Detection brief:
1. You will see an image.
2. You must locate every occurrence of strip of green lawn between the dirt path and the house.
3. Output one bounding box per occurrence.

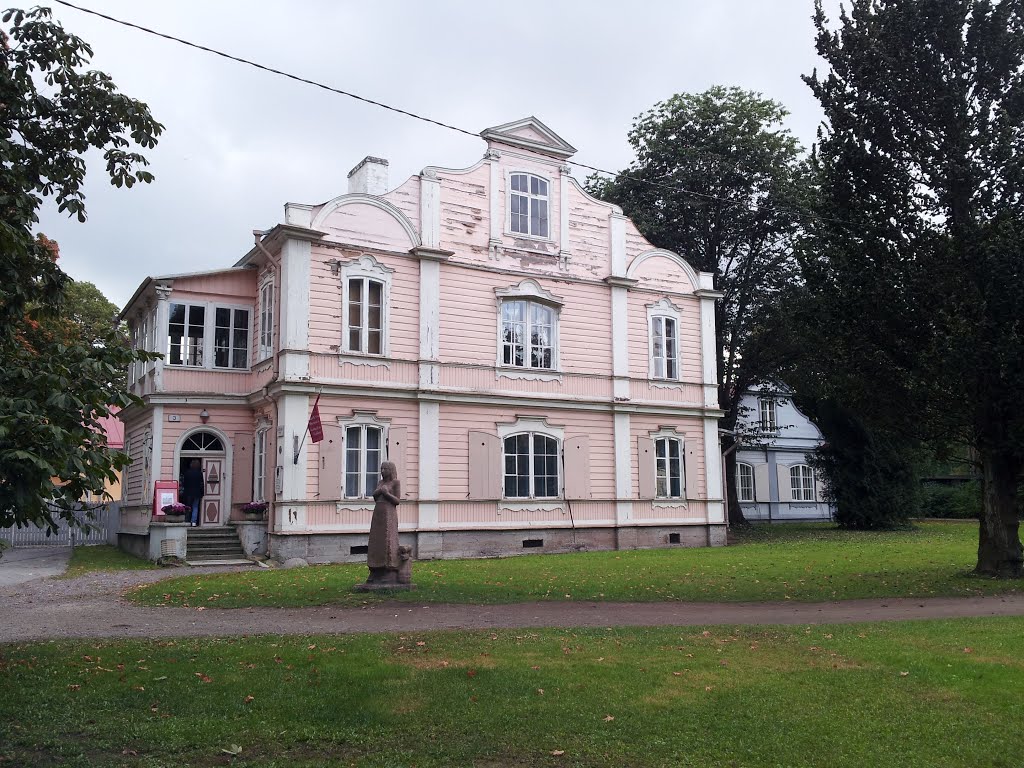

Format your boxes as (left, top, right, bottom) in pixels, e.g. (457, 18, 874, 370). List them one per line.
(128, 522, 1024, 608)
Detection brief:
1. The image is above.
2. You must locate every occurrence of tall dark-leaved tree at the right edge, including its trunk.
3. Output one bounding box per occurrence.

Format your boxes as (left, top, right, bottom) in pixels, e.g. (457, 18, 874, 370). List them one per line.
(802, 0, 1024, 575)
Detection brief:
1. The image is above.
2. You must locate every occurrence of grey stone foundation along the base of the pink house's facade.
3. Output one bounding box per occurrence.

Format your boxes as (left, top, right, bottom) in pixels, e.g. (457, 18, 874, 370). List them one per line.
(268, 525, 726, 563)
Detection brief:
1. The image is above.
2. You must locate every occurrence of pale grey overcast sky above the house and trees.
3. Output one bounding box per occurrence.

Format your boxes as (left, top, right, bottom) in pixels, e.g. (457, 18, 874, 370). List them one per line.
(32, 0, 839, 306)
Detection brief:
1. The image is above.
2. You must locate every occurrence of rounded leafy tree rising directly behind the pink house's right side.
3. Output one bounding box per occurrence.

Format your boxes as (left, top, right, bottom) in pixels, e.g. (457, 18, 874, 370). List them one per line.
(589, 87, 807, 523)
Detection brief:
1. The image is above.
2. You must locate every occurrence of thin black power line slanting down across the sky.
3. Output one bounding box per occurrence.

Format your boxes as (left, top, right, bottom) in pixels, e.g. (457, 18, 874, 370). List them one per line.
(53, 0, 853, 226)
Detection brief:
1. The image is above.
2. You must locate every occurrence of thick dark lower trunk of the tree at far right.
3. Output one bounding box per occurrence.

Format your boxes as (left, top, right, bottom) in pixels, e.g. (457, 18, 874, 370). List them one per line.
(975, 452, 1024, 579)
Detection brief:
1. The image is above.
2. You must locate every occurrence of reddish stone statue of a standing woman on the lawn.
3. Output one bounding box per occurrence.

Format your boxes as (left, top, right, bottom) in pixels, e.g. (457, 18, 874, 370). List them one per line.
(355, 462, 413, 592)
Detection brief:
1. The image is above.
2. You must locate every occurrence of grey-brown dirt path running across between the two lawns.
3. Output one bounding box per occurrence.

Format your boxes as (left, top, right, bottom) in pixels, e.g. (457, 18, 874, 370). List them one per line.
(0, 567, 1024, 642)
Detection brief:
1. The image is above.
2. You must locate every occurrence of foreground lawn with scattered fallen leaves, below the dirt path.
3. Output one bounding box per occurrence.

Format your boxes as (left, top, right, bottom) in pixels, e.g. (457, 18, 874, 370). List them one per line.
(0, 618, 1024, 768)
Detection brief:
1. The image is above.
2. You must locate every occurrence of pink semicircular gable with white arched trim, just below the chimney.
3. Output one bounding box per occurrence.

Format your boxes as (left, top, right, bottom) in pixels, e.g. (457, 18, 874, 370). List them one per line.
(310, 194, 420, 251)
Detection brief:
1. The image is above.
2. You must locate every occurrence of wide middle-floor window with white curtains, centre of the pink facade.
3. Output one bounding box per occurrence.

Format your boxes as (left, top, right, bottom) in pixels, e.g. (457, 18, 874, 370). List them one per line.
(495, 280, 563, 372)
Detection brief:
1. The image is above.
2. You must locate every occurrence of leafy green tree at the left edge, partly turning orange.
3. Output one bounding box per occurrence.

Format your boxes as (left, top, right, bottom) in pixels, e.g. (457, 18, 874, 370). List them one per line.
(0, 8, 163, 527)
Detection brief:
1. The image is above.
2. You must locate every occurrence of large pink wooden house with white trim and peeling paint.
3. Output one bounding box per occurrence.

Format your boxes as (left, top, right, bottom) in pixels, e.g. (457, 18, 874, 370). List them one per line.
(122, 118, 725, 561)
